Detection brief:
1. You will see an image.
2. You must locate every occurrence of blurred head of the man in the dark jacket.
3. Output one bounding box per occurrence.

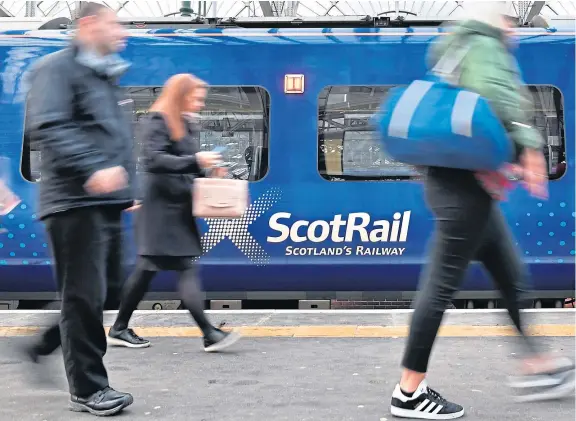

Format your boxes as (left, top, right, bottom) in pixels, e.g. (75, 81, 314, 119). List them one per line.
(76, 2, 126, 55)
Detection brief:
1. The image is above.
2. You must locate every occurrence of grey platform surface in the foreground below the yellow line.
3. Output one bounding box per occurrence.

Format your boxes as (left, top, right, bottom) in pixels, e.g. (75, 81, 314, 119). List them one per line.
(0, 337, 574, 421)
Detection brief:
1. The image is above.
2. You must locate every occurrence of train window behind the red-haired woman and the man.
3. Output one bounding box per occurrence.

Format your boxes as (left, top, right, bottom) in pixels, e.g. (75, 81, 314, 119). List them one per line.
(21, 86, 270, 182)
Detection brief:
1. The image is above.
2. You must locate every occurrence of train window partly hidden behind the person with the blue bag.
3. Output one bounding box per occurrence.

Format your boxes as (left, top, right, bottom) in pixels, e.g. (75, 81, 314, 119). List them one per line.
(318, 86, 566, 181)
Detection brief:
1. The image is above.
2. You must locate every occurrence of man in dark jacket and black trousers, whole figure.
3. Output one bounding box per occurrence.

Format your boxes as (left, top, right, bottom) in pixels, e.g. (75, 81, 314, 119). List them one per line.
(28, 2, 135, 416)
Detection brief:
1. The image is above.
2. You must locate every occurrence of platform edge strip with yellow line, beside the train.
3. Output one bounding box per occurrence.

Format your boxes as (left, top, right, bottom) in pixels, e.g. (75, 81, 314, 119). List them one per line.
(0, 309, 576, 338)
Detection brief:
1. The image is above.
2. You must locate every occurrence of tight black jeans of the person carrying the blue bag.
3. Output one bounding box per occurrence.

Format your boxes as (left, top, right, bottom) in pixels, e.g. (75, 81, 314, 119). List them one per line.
(403, 168, 535, 373)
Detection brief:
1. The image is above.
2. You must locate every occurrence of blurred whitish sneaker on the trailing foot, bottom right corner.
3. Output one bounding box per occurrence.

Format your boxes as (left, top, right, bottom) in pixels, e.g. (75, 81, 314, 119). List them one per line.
(509, 358, 576, 402)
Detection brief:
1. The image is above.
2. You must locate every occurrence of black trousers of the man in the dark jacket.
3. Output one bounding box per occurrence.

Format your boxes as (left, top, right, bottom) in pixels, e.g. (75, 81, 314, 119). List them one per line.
(36, 206, 123, 397)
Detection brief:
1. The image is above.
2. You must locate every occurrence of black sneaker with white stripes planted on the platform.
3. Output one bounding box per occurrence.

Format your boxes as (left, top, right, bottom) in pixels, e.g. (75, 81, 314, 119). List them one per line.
(390, 380, 464, 420)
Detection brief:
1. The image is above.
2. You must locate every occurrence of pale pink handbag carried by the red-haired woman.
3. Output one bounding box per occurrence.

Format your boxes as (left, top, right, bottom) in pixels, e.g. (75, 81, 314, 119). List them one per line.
(192, 177, 249, 218)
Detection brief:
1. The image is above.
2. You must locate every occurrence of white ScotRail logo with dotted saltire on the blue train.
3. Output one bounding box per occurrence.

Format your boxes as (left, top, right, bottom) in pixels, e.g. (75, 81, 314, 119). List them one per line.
(202, 188, 411, 266)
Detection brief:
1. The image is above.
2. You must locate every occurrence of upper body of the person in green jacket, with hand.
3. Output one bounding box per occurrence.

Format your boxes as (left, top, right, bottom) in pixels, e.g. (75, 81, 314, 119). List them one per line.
(427, 9, 547, 197)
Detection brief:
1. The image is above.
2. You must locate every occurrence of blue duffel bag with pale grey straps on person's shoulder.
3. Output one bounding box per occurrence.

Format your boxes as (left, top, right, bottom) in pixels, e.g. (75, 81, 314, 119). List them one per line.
(373, 40, 514, 171)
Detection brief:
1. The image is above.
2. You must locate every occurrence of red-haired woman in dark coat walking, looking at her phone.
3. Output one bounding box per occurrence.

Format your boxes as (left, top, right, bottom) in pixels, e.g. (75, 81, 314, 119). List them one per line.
(108, 74, 239, 352)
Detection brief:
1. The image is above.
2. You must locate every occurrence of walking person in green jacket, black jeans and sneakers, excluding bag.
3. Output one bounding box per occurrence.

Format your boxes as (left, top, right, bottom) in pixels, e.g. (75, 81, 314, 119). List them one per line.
(391, 2, 574, 420)
